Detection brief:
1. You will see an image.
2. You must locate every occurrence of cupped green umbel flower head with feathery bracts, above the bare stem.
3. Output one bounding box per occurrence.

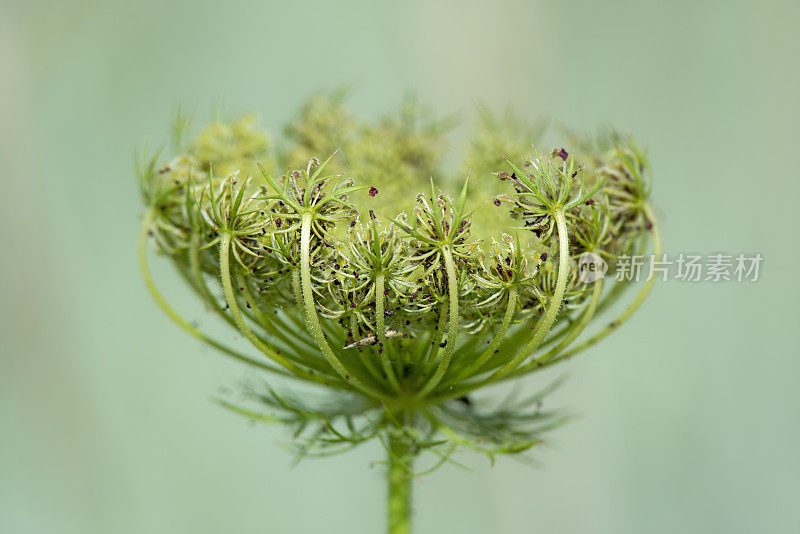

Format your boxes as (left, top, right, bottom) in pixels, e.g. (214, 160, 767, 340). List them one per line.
(138, 97, 660, 474)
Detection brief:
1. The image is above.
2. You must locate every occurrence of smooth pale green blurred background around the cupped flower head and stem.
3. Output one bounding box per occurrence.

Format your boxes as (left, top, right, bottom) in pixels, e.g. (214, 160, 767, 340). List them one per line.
(0, 0, 800, 534)
